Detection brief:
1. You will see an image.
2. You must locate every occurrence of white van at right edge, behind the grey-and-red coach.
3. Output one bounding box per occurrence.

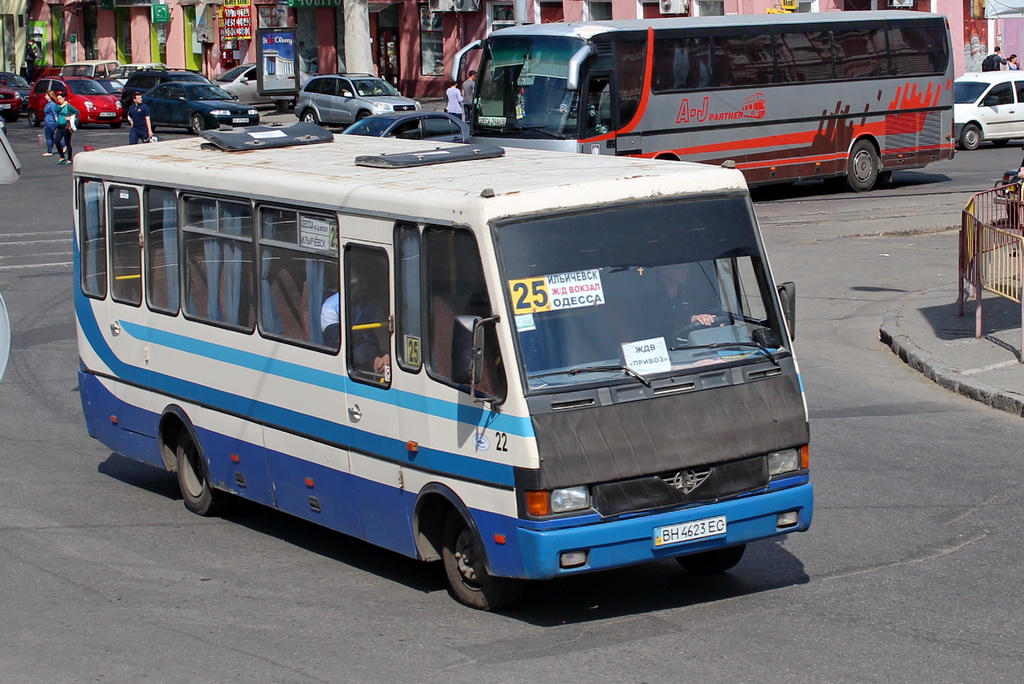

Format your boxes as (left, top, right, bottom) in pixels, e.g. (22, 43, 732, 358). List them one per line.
(953, 71, 1024, 149)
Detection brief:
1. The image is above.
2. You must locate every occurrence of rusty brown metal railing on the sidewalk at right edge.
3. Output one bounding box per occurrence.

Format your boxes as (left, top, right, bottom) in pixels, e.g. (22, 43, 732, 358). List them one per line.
(956, 182, 1024, 350)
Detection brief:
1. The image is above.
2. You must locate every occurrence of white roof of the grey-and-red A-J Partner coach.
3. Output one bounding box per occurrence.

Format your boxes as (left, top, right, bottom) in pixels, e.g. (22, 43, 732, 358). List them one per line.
(493, 10, 944, 39)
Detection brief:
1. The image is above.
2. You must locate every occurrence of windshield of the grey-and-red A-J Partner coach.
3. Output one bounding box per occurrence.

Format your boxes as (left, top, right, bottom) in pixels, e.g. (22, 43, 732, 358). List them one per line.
(474, 35, 584, 139)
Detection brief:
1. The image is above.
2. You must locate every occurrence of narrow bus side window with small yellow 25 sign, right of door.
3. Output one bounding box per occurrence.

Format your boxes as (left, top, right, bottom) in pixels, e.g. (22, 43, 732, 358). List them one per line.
(394, 222, 423, 373)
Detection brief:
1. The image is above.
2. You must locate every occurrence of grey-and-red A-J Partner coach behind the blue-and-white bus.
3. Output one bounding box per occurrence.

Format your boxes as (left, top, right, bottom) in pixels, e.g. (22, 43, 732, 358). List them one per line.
(455, 11, 955, 191)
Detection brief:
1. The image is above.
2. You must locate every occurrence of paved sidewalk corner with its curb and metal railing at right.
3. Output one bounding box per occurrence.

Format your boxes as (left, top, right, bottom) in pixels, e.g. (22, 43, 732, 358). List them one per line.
(880, 184, 1024, 417)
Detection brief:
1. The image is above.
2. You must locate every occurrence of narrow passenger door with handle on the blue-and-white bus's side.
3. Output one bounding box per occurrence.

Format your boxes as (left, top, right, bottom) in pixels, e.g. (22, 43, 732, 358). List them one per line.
(344, 237, 410, 553)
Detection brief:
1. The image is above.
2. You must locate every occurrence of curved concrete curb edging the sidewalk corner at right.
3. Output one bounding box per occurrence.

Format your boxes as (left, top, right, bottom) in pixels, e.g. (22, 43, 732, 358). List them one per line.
(879, 288, 1024, 418)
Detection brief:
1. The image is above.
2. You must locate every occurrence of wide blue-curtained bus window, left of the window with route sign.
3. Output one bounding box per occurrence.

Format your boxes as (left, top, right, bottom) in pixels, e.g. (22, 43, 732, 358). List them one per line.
(183, 197, 253, 330)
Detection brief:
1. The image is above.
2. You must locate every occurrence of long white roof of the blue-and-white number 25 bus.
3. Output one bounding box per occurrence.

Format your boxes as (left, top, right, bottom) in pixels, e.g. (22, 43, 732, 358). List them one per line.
(75, 135, 746, 223)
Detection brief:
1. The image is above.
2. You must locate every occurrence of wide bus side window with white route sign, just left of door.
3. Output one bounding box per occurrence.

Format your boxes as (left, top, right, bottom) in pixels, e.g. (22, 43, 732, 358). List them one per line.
(259, 207, 338, 351)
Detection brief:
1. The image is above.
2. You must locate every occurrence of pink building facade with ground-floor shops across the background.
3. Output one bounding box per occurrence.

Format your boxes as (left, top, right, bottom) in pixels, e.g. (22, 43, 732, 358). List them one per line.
(0, 0, 1011, 97)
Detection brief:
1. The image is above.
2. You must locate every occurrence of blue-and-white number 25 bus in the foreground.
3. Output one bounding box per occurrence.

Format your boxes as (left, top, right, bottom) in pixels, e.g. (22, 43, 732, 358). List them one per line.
(74, 124, 813, 609)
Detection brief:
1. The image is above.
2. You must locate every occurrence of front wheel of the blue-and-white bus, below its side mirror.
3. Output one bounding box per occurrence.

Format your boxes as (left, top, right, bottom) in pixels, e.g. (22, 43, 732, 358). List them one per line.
(441, 511, 522, 610)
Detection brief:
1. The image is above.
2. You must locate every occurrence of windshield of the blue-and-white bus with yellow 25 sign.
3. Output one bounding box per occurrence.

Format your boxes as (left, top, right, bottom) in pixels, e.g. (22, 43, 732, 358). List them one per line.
(497, 197, 788, 391)
